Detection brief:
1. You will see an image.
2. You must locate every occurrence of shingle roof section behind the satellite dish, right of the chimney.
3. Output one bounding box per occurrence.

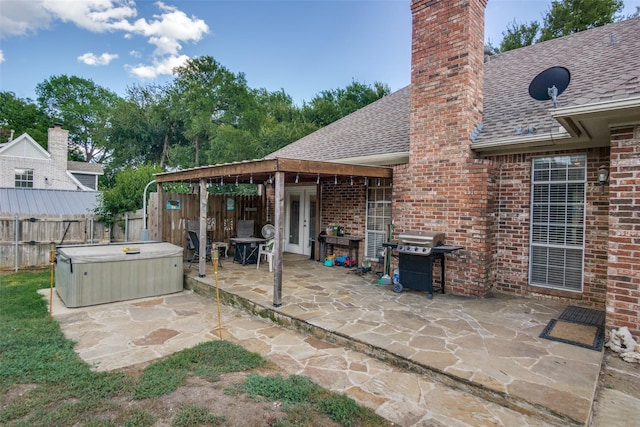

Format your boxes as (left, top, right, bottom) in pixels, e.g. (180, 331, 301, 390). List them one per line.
(476, 18, 640, 142)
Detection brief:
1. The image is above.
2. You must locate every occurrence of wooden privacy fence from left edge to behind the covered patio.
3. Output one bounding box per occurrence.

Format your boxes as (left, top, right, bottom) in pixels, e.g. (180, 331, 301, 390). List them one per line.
(0, 193, 266, 271)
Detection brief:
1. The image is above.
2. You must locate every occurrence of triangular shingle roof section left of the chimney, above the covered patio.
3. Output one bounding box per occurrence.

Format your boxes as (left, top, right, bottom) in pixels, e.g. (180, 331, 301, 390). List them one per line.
(266, 86, 411, 161)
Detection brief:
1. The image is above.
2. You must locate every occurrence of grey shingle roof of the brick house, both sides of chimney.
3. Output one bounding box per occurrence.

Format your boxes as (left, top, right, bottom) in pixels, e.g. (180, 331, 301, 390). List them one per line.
(267, 17, 640, 160)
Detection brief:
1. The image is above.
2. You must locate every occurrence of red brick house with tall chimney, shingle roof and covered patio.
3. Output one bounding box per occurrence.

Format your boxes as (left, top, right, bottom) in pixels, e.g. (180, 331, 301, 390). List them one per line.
(157, 0, 640, 336)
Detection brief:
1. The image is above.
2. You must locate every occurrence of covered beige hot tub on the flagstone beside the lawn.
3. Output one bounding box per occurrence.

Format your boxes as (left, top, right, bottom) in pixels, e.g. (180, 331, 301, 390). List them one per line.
(55, 242, 183, 307)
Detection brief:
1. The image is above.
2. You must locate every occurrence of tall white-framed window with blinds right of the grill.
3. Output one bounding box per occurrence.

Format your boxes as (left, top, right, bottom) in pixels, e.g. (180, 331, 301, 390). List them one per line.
(529, 155, 587, 291)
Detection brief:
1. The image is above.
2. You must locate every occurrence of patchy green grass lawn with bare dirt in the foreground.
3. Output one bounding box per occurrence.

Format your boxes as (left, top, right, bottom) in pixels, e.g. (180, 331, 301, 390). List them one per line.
(0, 272, 390, 427)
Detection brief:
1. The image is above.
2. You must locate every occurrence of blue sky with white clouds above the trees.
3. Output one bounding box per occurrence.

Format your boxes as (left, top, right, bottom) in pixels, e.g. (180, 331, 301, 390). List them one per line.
(0, 0, 640, 105)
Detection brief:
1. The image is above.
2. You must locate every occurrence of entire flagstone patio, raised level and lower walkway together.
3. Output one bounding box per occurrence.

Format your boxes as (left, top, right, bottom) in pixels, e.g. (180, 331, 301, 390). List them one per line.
(45, 257, 636, 426)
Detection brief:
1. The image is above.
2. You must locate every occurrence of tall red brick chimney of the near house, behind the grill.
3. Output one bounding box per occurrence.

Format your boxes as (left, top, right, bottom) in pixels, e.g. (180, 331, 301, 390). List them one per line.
(394, 0, 493, 296)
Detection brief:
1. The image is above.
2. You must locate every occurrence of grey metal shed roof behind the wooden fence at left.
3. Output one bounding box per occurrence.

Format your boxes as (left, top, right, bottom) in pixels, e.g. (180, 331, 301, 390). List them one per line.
(0, 188, 100, 215)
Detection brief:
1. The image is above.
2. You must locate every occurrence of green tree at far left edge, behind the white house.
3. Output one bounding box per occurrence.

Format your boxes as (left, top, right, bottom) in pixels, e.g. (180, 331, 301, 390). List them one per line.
(0, 92, 50, 148)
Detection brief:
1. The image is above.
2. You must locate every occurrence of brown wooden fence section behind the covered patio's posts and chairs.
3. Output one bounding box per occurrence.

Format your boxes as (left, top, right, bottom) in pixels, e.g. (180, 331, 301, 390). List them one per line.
(160, 193, 265, 247)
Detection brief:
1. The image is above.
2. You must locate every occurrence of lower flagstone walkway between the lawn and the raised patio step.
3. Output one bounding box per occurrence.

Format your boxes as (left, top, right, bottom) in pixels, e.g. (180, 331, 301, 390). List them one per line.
(43, 291, 547, 426)
